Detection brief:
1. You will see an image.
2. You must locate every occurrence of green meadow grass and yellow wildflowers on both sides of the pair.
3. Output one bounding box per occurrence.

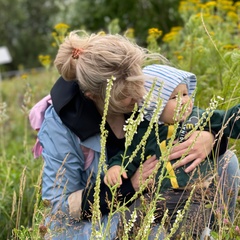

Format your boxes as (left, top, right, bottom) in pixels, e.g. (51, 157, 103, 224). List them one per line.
(0, 0, 240, 240)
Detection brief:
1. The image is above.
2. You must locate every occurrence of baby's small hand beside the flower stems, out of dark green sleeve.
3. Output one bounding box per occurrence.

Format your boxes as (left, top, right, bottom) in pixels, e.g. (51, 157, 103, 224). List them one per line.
(104, 165, 128, 186)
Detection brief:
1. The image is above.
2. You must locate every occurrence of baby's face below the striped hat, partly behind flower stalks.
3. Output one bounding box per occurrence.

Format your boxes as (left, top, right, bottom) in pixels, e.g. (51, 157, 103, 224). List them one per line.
(160, 84, 193, 124)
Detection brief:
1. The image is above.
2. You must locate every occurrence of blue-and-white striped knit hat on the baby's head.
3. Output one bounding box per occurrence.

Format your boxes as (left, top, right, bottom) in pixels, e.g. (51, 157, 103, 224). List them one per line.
(140, 64, 197, 124)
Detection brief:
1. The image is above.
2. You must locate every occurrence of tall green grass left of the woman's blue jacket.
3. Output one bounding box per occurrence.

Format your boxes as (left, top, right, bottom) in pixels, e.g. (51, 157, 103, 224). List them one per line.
(0, 65, 240, 239)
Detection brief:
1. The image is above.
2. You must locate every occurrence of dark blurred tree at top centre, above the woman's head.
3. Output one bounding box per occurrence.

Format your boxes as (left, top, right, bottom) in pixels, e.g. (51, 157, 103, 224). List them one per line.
(69, 0, 182, 45)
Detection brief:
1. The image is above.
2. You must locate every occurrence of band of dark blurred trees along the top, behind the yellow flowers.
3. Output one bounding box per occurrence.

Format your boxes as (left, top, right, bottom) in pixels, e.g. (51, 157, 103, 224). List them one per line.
(0, 0, 191, 70)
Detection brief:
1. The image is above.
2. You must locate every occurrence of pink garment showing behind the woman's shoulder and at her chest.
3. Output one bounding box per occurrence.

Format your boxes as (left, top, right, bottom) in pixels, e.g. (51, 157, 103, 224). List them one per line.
(29, 95, 94, 170)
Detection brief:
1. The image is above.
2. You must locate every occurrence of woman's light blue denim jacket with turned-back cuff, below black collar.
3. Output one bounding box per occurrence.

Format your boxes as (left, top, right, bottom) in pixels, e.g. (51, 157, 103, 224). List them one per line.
(38, 105, 119, 240)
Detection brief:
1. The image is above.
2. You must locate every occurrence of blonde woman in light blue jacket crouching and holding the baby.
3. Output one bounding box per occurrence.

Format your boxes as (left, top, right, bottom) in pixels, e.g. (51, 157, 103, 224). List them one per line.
(29, 32, 238, 239)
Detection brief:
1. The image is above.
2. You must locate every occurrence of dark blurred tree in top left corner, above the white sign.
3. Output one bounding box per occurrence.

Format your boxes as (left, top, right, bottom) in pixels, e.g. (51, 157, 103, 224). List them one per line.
(0, 0, 59, 69)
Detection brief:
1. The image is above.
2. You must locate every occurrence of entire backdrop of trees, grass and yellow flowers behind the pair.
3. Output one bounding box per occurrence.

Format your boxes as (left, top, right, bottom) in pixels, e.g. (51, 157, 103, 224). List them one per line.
(0, 0, 240, 239)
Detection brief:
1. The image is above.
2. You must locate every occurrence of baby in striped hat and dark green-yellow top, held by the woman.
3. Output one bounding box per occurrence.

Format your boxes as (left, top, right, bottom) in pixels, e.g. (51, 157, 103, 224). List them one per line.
(104, 65, 240, 236)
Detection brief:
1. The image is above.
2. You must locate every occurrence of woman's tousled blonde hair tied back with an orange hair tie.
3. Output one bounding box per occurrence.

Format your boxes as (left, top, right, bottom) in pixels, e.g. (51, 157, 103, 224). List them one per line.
(54, 31, 165, 112)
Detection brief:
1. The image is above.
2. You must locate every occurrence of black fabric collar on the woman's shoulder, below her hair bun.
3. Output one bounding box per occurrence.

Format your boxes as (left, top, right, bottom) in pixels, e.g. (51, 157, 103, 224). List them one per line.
(50, 77, 102, 141)
